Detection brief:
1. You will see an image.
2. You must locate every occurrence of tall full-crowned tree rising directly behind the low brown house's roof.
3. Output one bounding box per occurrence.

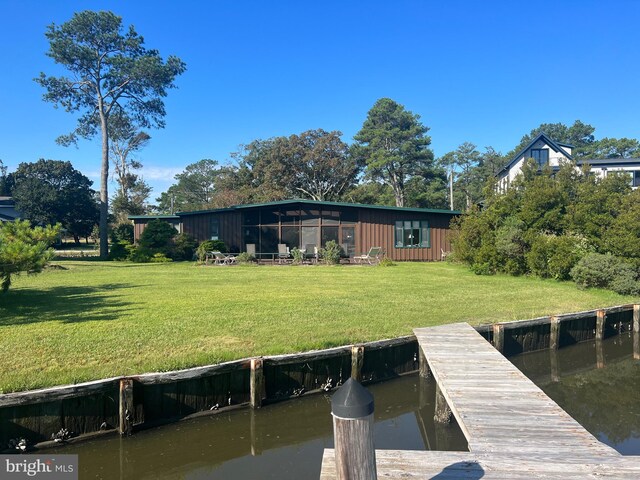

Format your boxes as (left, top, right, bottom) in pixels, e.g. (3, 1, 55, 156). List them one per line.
(353, 98, 434, 207)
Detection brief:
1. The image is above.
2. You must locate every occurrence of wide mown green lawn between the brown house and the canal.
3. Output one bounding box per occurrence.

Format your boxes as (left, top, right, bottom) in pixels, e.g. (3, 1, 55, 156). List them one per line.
(0, 261, 638, 393)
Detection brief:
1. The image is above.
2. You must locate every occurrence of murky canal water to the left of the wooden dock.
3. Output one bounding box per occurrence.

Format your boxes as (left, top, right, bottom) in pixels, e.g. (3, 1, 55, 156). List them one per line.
(50, 375, 467, 480)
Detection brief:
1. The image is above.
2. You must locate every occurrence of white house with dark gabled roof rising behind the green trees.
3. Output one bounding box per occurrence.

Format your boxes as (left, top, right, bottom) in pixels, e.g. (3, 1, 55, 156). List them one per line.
(496, 133, 640, 192)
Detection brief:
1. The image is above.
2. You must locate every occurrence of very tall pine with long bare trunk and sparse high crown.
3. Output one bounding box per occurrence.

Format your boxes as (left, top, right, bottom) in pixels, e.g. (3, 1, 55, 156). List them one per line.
(36, 10, 185, 258)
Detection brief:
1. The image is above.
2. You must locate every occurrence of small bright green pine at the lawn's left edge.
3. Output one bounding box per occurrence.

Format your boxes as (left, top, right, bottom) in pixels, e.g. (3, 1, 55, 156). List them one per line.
(0, 220, 60, 292)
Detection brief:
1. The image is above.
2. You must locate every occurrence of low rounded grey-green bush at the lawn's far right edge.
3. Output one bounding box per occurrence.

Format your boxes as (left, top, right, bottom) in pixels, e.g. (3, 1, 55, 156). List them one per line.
(571, 253, 639, 294)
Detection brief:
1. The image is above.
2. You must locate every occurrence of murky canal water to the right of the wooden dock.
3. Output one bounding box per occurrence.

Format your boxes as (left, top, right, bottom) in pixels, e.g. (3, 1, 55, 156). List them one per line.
(510, 333, 640, 455)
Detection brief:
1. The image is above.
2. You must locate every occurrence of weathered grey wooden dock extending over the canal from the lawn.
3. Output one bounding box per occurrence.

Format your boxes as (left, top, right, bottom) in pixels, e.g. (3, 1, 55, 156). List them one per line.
(320, 323, 640, 480)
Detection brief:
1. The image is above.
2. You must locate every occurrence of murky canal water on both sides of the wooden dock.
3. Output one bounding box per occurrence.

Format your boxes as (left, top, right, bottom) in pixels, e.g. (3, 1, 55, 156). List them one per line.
(54, 333, 640, 480)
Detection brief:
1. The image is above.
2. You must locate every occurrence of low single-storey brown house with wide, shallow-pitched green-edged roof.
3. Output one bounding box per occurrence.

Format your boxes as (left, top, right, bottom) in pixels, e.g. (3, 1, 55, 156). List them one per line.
(129, 200, 460, 261)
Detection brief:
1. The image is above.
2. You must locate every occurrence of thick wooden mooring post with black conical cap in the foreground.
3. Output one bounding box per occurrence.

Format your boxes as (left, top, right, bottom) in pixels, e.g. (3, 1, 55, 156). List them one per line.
(331, 378, 377, 480)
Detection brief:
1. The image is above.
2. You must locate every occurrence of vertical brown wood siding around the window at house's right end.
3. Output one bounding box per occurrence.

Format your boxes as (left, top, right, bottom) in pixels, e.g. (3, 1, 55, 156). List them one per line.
(356, 208, 453, 261)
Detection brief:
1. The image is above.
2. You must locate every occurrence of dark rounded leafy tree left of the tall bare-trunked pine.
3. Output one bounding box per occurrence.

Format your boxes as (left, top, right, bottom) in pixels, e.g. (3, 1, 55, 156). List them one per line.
(13, 159, 98, 243)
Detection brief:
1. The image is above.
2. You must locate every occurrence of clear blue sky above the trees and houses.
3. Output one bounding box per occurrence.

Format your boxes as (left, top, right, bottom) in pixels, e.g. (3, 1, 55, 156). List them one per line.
(0, 0, 640, 198)
